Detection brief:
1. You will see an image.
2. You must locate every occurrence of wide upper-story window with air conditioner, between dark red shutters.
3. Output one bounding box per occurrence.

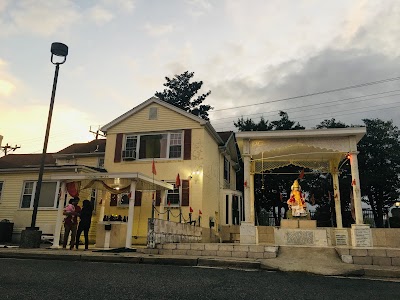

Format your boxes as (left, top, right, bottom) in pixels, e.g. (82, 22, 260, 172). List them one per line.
(122, 132, 183, 160)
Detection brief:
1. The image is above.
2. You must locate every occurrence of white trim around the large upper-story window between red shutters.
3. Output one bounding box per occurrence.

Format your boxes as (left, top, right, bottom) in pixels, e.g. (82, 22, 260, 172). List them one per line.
(122, 130, 185, 161)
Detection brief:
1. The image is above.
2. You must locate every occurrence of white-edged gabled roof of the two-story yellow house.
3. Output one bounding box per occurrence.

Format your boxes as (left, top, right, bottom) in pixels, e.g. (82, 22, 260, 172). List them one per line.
(101, 97, 224, 146)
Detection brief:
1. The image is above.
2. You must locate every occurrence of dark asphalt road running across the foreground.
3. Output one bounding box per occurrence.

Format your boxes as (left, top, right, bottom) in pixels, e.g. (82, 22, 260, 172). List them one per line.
(0, 259, 400, 300)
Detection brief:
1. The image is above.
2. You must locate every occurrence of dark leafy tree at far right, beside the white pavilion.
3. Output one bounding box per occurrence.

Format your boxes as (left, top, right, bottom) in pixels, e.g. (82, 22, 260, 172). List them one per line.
(358, 119, 400, 227)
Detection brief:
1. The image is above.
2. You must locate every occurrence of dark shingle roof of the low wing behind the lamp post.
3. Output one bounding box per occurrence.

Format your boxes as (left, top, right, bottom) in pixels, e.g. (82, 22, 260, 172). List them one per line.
(0, 153, 56, 169)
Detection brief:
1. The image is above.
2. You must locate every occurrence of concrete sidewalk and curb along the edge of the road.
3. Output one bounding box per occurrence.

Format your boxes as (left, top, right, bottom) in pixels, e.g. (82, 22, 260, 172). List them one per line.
(0, 244, 400, 279)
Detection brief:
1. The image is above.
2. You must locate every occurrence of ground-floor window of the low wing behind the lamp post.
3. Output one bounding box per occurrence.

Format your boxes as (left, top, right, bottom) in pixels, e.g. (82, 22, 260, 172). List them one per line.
(21, 181, 59, 208)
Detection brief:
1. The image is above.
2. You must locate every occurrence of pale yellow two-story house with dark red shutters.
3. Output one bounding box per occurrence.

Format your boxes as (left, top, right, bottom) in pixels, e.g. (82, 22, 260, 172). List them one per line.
(0, 97, 244, 246)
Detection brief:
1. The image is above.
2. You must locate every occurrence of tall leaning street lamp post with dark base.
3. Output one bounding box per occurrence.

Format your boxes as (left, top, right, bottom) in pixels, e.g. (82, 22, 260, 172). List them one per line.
(20, 43, 68, 248)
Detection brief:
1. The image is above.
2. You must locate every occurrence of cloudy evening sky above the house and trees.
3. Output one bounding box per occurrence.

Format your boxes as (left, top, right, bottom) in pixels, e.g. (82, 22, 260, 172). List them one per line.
(0, 0, 400, 153)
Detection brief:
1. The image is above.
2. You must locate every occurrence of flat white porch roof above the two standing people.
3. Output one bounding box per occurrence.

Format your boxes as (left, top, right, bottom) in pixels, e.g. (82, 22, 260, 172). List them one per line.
(50, 172, 173, 191)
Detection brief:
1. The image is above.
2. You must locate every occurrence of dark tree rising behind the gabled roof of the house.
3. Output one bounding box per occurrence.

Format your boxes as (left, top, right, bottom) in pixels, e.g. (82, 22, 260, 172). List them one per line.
(155, 71, 213, 120)
